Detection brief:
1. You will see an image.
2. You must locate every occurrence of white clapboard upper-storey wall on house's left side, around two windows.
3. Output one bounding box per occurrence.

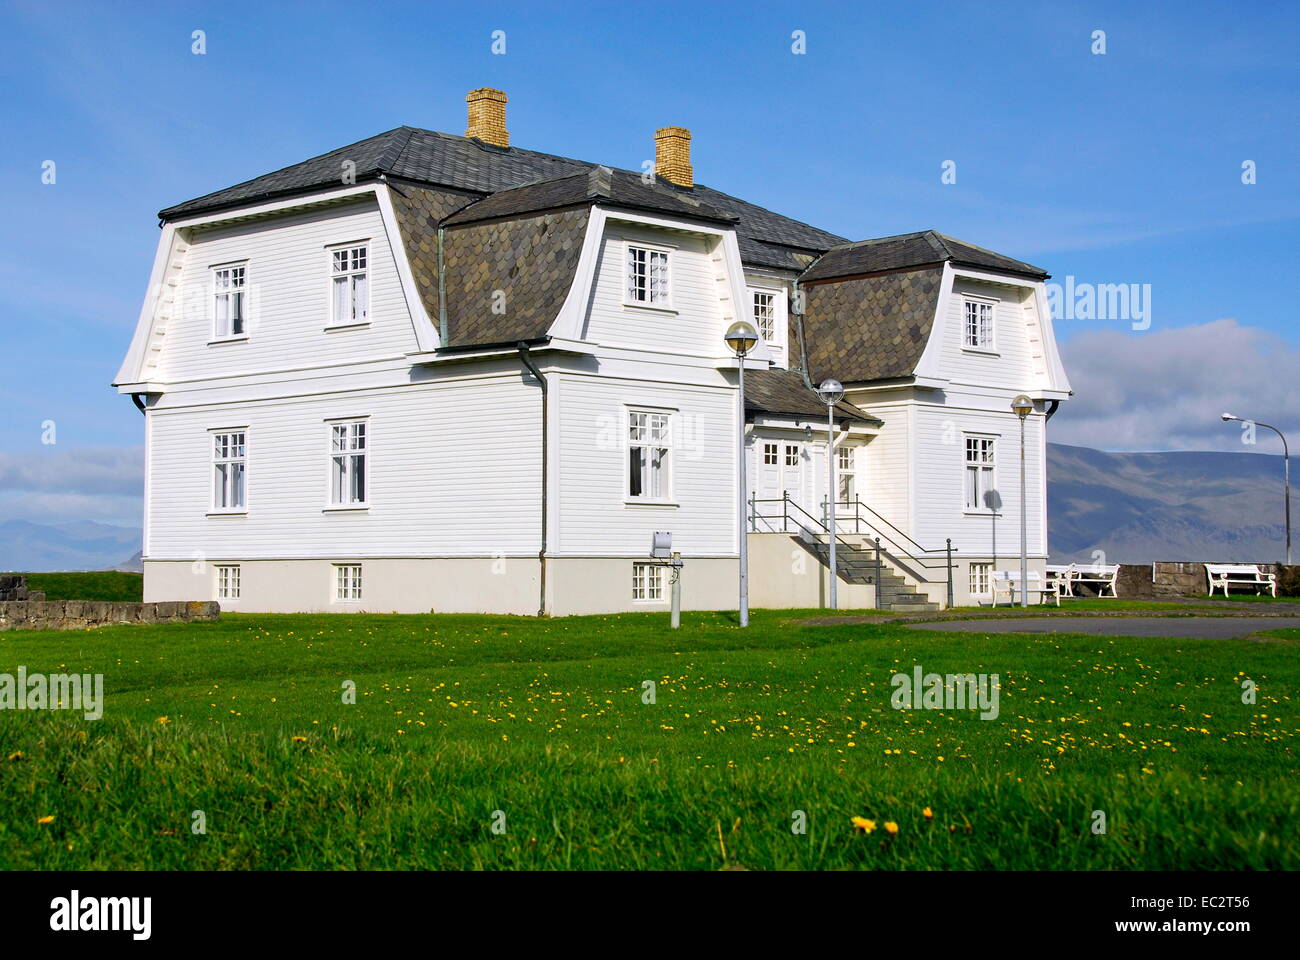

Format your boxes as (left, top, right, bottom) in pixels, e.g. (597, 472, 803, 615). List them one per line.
(159, 199, 416, 382)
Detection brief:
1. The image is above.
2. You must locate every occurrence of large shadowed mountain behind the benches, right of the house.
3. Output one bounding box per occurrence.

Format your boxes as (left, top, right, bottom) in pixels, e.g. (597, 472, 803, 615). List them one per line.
(1048, 444, 1300, 563)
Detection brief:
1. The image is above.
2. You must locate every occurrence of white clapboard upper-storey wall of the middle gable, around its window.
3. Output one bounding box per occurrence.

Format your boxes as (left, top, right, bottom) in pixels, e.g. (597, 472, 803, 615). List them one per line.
(582, 220, 725, 356)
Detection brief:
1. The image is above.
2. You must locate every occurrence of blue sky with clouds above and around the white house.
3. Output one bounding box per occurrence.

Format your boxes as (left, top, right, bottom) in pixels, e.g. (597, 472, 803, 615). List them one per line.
(0, 0, 1300, 522)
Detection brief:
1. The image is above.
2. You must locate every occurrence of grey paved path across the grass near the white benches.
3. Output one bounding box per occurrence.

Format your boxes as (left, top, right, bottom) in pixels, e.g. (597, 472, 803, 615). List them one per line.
(907, 617, 1300, 640)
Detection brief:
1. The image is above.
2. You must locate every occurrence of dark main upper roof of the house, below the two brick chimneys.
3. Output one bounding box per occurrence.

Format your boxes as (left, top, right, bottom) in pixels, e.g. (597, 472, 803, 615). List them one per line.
(159, 126, 845, 269)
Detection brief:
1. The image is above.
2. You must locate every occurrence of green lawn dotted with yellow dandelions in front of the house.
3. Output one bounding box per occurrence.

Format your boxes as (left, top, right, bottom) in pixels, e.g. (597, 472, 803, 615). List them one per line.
(0, 610, 1300, 870)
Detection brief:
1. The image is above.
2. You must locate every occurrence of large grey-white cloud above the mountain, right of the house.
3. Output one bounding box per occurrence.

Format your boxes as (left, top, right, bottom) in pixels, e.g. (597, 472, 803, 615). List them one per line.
(1048, 319, 1300, 453)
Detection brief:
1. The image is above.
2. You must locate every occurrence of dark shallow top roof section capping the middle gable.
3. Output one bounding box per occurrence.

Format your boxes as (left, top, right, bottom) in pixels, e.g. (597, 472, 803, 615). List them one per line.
(445, 167, 738, 226)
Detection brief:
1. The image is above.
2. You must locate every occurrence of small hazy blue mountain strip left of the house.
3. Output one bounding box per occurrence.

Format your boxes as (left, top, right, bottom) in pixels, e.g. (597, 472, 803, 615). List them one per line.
(0, 520, 143, 572)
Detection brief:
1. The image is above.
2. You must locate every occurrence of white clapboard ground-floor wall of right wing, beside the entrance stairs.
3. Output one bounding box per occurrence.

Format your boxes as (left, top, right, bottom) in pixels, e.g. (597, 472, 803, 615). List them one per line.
(913, 401, 1045, 557)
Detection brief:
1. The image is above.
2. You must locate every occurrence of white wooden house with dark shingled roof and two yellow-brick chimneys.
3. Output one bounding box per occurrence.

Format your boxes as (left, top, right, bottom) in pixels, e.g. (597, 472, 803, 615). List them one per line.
(114, 90, 1070, 614)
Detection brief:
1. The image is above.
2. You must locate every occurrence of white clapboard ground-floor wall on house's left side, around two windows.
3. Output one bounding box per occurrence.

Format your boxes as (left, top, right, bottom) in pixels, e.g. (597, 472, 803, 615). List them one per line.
(146, 376, 541, 559)
